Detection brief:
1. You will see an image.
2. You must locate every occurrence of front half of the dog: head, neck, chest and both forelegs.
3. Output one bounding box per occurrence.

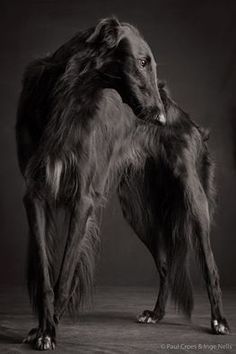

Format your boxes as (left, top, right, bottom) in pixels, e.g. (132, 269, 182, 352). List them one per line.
(16, 19, 165, 350)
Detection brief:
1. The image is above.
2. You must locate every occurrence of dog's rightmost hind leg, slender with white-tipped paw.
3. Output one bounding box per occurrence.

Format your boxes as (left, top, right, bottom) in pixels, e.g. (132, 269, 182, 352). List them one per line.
(187, 173, 229, 334)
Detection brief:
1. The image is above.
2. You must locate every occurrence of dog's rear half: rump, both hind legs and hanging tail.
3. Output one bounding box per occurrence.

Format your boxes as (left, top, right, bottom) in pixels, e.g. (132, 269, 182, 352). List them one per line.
(118, 83, 229, 334)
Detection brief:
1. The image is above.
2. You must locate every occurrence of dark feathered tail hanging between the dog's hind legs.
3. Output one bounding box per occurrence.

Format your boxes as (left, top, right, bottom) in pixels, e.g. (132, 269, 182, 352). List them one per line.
(168, 211, 194, 318)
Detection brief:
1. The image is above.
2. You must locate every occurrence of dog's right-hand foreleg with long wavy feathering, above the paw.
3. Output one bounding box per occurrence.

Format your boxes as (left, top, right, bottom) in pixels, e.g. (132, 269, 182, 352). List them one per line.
(55, 195, 98, 323)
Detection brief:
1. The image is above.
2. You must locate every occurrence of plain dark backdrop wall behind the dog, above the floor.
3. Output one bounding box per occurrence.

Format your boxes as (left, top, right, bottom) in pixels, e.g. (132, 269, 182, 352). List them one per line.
(0, 0, 236, 286)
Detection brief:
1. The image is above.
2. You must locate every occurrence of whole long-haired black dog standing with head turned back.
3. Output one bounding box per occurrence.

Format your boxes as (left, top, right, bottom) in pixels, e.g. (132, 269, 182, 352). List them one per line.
(16, 18, 228, 350)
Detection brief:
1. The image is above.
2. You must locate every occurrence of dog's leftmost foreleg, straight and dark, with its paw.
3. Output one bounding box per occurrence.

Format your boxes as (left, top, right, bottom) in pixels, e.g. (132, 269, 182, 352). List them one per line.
(24, 194, 56, 350)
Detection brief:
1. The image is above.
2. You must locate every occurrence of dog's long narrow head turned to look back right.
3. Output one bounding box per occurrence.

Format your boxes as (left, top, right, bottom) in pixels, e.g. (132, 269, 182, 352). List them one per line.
(87, 18, 166, 124)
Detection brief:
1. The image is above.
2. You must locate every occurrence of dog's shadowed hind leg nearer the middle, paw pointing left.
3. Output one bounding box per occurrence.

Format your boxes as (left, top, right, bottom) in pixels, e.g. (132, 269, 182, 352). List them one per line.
(118, 174, 169, 324)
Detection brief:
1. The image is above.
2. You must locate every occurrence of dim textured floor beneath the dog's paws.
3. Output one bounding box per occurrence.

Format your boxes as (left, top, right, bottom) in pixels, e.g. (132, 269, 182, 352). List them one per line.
(0, 288, 236, 354)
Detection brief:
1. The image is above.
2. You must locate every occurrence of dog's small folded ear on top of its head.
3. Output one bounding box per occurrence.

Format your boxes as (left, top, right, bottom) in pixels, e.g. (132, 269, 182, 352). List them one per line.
(87, 17, 120, 49)
